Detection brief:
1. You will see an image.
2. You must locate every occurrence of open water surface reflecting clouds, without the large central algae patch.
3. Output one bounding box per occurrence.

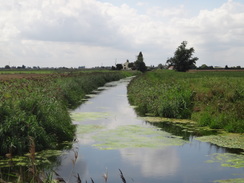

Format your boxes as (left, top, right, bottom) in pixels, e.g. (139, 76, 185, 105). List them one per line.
(57, 77, 244, 183)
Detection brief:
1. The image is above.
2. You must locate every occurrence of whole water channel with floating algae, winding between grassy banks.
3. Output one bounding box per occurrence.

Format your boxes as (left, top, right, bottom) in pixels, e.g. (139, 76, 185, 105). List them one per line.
(55, 79, 244, 183)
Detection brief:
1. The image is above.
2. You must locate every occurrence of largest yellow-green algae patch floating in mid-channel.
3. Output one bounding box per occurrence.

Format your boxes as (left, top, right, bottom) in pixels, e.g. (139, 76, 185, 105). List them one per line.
(93, 125, 187, 150)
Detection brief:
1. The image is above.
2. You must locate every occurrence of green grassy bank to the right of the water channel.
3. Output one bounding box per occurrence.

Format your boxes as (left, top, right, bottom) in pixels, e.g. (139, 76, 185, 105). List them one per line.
(128, 70, 244, 133)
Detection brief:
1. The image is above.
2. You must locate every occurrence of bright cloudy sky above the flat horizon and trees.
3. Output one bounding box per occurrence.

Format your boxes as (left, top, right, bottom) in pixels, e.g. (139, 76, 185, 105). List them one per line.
(0, 0, 244, 67)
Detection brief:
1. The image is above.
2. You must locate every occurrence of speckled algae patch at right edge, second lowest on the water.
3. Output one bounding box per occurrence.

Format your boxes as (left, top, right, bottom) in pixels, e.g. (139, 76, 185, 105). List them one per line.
(207, 153, 244, 168)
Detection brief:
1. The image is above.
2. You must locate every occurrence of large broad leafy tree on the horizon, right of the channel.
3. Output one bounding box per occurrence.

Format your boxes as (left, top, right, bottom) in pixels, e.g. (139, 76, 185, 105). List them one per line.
(166, 41, 198, 72)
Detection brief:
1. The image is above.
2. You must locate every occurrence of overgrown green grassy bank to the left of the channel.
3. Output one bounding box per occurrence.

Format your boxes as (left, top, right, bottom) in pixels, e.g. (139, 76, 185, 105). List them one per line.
(0, 72, 135, 155)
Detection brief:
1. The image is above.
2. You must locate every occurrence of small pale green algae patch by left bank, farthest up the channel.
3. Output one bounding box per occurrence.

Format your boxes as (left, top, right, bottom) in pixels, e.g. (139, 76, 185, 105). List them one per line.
(71, 112, 110, 121)
